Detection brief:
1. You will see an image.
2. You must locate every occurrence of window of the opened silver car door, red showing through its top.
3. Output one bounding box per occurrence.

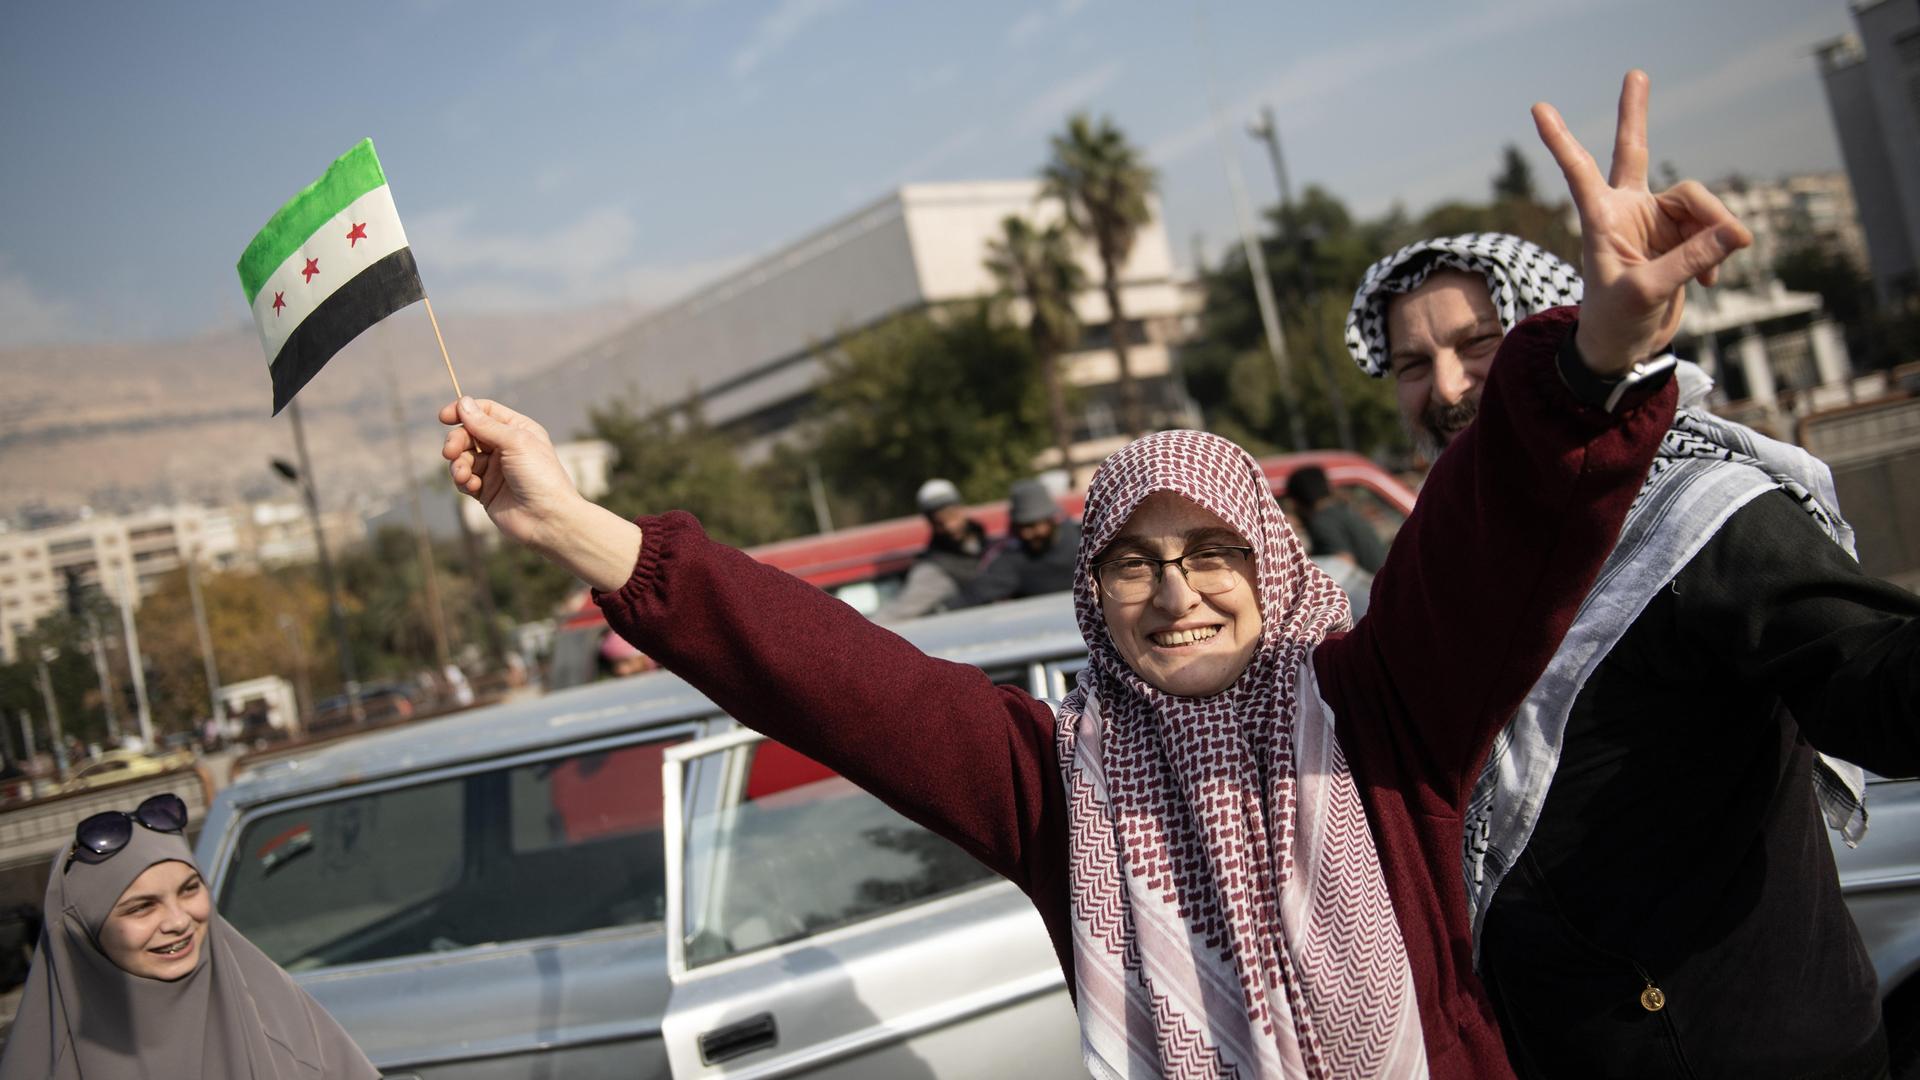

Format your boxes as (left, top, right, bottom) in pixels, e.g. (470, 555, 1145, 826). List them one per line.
(684, 742, 993, 967)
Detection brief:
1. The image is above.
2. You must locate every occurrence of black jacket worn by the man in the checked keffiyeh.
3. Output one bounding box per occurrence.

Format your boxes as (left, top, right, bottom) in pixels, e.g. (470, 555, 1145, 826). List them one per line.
(1480, 492, 1920, 1078)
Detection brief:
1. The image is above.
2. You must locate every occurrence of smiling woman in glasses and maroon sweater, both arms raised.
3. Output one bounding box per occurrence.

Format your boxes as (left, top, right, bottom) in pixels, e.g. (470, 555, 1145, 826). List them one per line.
(442, 73, 1747, 1080)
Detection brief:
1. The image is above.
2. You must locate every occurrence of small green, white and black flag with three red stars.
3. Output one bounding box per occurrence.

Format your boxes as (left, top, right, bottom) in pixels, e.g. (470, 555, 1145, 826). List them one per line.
(238, 138, 426, 415)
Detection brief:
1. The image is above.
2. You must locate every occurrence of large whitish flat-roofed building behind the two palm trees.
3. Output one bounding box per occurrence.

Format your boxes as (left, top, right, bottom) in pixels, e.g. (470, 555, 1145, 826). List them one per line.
(513, 181, 1190, 472)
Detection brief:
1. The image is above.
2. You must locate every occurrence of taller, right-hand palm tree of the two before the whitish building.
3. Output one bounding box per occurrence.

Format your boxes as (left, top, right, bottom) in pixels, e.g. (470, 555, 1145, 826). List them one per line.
(1041, 113, 1158, 436)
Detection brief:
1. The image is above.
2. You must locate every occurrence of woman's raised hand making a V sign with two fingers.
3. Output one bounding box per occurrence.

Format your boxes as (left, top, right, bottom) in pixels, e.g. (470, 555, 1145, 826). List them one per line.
(1534, 71, 1753, 375)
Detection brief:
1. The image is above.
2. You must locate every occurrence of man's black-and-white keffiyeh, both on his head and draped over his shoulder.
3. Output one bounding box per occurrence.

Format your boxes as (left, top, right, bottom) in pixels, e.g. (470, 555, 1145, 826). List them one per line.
(1346, 233, 1866, 963)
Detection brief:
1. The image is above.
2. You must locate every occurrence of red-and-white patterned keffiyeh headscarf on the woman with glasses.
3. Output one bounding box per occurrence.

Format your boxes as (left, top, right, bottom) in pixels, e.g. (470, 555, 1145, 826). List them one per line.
(1058, 430, 1427, 1080)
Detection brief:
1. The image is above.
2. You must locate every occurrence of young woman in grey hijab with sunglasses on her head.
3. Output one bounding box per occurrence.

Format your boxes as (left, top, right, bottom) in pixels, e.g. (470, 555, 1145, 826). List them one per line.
(0, 796, 380, 1080)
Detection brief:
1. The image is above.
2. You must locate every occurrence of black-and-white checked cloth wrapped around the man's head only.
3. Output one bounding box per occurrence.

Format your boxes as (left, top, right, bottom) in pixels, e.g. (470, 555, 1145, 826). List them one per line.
(1346, 233, 1580, 379)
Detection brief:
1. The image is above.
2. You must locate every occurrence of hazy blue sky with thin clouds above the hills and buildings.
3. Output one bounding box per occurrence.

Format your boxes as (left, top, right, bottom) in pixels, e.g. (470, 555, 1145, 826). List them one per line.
(0, 0, 1851, 346)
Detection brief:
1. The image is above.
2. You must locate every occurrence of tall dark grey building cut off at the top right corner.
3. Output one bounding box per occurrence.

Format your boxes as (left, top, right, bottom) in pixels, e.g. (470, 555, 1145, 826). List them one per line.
(1814, 0, 1920, 304)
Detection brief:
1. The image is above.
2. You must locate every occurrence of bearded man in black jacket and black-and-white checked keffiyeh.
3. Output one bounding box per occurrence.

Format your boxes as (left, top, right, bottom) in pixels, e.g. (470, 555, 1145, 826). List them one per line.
(1346, 224, 1920, 1078)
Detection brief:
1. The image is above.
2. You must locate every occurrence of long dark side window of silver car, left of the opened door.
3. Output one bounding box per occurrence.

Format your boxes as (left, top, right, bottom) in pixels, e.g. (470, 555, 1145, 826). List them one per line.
(219, 730, 683, 970)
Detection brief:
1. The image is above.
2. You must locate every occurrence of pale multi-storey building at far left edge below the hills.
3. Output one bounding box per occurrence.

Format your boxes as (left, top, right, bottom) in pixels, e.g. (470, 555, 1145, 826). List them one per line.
(0, 505, 240, 659)
